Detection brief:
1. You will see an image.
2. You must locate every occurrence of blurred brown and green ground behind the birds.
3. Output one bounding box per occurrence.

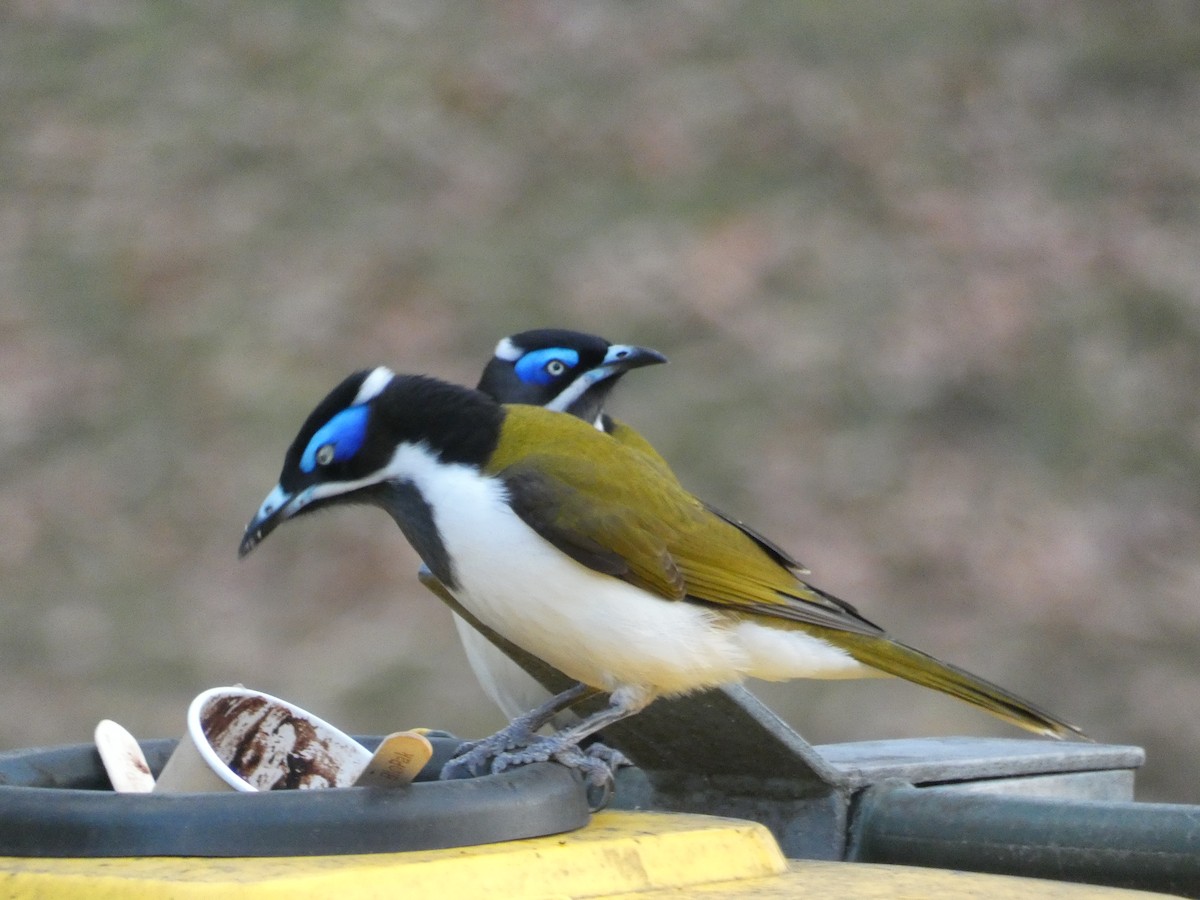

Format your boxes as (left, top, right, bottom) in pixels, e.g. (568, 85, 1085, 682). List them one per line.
(0, 0, 1200, 803)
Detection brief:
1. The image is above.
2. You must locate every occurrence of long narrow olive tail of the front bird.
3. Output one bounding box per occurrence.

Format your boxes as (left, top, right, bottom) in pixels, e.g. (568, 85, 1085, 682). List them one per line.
(839, 635, 1091, 740)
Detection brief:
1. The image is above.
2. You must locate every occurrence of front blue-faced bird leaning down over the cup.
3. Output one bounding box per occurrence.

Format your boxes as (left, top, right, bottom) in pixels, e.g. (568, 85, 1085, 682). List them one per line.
(239, 367, 1081, 782)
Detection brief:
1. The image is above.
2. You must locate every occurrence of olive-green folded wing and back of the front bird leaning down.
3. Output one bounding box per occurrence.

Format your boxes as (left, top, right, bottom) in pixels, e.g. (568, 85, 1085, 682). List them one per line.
(488, 407, 880, 635)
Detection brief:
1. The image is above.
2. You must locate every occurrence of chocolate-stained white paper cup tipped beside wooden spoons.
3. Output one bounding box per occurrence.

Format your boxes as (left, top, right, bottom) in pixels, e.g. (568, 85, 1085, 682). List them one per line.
(154, 688, 371, 793)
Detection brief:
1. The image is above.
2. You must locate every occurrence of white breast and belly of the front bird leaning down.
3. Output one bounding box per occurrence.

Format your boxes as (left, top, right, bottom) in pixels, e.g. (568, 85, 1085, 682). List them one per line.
(389, 445, 870, 696)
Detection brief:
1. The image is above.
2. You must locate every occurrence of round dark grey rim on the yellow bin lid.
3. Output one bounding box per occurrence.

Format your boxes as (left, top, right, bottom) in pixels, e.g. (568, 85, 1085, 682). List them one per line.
(0, 738, 589, 857)
